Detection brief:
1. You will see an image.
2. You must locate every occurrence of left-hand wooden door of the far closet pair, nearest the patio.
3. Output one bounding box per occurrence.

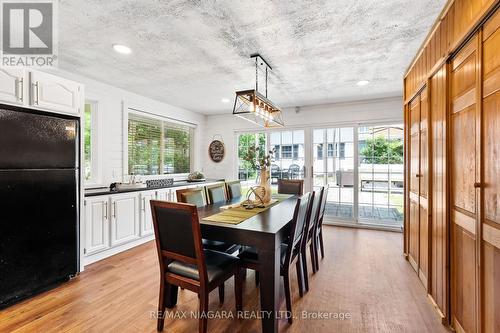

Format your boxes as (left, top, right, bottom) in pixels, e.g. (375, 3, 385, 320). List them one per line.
(408, 95, 420, 272)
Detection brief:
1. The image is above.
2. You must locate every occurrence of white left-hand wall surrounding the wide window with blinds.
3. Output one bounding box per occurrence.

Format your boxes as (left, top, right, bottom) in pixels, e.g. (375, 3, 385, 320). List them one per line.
(44, 71, 205, 186)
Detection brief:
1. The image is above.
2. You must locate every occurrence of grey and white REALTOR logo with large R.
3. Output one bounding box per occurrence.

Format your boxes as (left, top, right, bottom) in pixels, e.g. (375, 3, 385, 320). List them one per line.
(1, 0, 57, 66)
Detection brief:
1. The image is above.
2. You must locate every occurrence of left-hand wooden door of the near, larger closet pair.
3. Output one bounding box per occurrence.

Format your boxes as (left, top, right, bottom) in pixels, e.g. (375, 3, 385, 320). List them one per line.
(450, 36, 480, 332)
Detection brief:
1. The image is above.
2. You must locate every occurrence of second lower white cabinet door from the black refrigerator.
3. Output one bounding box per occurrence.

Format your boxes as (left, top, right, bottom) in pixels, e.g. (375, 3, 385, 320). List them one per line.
(111, 194, 139, 246)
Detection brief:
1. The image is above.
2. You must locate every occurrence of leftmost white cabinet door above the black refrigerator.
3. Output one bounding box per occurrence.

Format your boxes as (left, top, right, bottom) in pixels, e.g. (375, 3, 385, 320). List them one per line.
(0, 67, 27, 105)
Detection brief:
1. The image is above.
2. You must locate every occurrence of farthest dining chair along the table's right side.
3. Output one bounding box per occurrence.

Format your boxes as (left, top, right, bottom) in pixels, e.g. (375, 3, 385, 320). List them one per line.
(301, 187, 324, 291)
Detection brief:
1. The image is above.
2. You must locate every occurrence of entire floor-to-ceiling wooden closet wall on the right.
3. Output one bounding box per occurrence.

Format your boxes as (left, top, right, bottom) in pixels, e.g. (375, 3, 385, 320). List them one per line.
(404, 0, 500, 332)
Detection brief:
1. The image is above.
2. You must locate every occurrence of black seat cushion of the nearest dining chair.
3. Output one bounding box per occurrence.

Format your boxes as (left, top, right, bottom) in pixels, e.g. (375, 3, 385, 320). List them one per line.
(167, 250, 239, 283)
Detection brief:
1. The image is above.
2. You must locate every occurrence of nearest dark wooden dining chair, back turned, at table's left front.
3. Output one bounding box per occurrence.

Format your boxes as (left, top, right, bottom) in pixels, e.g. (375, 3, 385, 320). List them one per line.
(151, 200, 242, 333)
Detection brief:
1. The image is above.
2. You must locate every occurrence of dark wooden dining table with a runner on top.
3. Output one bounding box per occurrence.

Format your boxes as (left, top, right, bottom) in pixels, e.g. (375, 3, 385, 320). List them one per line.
(163, 196, 297, 333)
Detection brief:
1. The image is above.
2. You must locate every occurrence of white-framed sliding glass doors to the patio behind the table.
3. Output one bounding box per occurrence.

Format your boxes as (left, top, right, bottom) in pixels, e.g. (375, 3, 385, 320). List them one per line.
(237, 124, 404, 228)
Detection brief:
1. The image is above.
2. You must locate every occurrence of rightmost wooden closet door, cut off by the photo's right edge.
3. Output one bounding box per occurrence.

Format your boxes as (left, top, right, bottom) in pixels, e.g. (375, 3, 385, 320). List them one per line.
(481, 13, 500, 333)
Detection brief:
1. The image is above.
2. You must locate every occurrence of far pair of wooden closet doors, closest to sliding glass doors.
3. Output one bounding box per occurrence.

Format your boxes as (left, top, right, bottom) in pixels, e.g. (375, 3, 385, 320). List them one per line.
(408, 88, 430, 287)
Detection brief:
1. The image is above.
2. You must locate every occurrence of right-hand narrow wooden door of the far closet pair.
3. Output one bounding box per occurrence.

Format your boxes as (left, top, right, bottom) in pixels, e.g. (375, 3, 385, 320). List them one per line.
(415, 87, 430, 289)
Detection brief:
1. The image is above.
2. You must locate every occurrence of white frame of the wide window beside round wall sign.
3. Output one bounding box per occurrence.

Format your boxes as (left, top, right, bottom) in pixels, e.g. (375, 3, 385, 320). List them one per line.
(122, 102, 197, 181)
